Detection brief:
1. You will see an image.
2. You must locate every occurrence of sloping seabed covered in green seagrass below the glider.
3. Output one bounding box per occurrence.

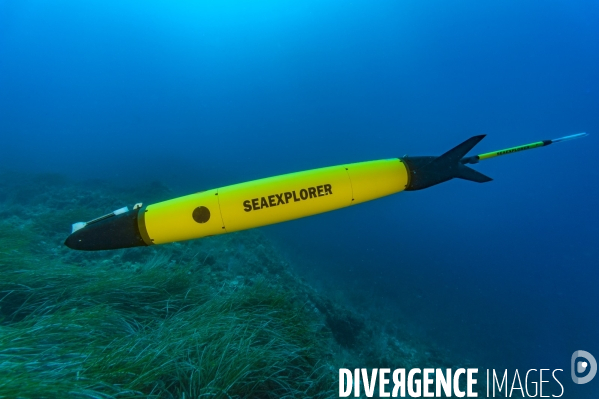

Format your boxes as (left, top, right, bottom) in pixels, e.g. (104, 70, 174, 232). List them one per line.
(0, 173, 492, 399)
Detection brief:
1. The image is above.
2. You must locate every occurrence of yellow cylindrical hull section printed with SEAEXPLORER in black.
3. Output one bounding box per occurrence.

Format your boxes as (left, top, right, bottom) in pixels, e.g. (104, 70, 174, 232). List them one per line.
(139, 158, 408, 245)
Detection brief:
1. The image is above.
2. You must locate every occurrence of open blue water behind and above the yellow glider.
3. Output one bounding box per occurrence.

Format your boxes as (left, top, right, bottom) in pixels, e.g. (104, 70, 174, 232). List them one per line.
(0, 0, 599, 397)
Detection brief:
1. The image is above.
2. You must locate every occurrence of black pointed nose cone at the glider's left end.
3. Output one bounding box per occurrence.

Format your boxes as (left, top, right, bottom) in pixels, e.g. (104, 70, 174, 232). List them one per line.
(64, 209, 147, 251)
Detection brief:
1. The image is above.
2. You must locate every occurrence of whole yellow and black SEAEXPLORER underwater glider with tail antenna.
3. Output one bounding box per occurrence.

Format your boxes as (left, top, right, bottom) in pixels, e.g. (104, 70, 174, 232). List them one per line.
(65, 133, 587, 251)
